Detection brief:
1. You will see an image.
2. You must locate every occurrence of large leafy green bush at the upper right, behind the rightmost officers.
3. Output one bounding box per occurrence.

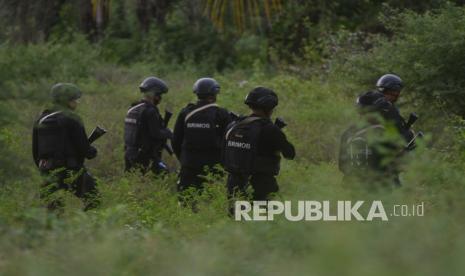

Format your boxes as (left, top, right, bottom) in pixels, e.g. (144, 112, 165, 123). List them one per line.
(344, 4, 465, 116)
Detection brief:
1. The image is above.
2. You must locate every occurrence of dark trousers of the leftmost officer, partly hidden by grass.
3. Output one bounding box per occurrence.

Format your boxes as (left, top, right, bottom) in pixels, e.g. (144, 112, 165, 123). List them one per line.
(40, 168, 99, 210)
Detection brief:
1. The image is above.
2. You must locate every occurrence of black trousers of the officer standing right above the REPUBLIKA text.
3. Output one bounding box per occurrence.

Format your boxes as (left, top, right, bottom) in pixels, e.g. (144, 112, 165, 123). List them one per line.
(227, 173, 279, 200)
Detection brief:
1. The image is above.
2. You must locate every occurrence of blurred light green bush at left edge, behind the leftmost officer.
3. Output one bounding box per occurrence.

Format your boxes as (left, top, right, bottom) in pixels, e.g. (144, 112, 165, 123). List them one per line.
(0, 37, 98, 99)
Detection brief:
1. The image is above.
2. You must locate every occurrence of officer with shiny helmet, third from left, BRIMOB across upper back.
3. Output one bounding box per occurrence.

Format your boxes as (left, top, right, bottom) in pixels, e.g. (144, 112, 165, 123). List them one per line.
(172, 78, 231, 191)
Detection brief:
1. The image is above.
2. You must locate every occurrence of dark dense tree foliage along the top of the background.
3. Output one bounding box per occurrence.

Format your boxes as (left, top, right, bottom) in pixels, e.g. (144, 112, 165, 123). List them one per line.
(0, 0, 462, 71)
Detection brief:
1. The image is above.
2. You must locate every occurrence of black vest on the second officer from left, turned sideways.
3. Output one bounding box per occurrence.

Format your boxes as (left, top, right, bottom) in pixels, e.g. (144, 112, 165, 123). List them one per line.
(124, 103, 147, 149)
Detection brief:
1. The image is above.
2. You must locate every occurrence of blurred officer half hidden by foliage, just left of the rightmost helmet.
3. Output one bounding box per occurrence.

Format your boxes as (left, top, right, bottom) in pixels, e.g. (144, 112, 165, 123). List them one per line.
(339, 92, 403, 189)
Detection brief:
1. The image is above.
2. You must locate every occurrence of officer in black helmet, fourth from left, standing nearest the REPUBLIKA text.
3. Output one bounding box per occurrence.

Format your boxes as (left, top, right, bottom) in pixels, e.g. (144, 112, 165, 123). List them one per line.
(224, 87, 295, 200)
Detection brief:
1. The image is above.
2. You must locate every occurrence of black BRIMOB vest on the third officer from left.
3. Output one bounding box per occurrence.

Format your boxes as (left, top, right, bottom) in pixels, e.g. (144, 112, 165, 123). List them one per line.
(182, 104, 223, 151)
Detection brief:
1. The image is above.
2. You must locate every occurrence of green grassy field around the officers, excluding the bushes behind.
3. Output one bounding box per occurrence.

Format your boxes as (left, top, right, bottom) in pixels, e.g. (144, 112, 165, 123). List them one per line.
(0, 61, 465, 276)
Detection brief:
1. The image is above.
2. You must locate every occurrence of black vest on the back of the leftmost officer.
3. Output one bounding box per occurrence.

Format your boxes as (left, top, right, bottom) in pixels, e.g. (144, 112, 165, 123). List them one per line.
(36, 111, 70, 160)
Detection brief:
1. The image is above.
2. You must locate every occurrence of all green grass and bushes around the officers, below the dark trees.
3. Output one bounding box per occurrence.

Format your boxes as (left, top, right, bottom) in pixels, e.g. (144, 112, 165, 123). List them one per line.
(0, 4, 465, 276)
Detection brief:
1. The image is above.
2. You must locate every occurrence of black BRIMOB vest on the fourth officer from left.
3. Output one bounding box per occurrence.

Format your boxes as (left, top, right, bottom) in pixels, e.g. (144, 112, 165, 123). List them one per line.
(224, 117, 280, 175)
